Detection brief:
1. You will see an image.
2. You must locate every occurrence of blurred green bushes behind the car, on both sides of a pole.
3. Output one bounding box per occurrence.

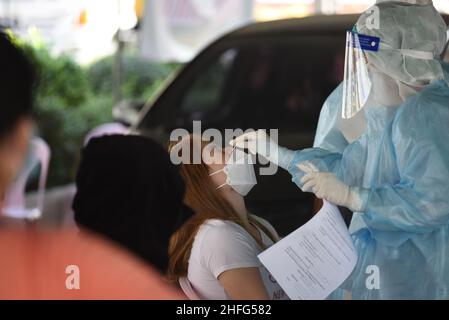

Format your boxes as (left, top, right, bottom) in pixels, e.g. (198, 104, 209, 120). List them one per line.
(17, 41, 175, 187)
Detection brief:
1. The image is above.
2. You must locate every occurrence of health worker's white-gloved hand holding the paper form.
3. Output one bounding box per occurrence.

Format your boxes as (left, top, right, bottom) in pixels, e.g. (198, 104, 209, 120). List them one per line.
(298, 165, 367, 212)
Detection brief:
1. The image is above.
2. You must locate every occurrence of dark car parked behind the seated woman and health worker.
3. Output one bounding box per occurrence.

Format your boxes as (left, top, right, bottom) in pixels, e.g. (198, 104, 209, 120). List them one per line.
(137, 15, 449, 235)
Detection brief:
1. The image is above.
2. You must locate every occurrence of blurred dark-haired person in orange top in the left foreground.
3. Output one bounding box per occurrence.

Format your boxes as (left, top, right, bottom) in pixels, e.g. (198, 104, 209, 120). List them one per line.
(0, 31, 183, 299)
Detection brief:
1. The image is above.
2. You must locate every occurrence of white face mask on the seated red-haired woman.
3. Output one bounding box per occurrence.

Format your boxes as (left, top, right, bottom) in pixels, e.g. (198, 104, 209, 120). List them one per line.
(210, 149, 257, 196)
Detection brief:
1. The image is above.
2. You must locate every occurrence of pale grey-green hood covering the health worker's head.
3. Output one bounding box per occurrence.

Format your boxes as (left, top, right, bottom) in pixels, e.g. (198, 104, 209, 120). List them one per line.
(356, 0, 447, 87)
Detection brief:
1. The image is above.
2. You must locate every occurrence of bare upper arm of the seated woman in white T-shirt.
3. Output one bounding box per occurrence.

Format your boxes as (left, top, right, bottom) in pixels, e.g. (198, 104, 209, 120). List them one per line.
(218, 268, 269, 300)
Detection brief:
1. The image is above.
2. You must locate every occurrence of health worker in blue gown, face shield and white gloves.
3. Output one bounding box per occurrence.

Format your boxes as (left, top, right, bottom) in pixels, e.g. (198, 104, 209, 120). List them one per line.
(231, 0, 449, 299)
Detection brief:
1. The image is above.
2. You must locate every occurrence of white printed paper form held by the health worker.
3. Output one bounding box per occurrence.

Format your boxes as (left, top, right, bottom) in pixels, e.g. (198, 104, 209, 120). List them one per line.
(259, 201, 357, 300)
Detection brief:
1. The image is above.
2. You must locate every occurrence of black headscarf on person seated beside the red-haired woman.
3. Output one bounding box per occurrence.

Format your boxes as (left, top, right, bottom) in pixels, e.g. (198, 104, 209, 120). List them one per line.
(73, 135, 191, 272)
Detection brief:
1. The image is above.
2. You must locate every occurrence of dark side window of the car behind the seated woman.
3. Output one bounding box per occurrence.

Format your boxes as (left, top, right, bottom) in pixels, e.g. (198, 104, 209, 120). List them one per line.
(172, 37, 344, 132)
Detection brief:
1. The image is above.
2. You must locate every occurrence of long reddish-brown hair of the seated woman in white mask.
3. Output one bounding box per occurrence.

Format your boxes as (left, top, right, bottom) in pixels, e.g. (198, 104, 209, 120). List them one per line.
(167, 135, 276, 281)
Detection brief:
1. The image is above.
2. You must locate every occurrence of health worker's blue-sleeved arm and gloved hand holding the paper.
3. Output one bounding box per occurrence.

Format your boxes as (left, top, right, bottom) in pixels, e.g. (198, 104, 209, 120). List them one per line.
(302, 101, 449, 233)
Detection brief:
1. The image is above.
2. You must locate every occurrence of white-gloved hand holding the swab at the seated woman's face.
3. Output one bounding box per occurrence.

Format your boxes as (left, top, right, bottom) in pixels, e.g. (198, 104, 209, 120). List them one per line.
(229, 129, 294, 170)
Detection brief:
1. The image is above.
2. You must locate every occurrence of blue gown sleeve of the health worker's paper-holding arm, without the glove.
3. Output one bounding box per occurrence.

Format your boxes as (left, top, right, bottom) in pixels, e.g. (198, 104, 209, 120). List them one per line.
(364, 101, 449, 233)
